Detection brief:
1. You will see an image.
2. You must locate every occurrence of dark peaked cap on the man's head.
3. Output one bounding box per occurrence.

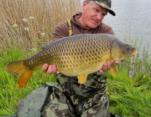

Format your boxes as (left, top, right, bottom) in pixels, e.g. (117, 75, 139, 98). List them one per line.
(91, 0, 115, 16)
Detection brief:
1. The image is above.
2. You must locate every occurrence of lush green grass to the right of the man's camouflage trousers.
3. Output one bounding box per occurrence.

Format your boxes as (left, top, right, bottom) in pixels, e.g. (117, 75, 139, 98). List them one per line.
(108, 62, 151, 117)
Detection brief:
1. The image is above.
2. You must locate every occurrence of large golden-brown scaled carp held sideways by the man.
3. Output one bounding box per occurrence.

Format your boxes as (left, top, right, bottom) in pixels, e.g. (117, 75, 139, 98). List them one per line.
(7, 34, 137, 87)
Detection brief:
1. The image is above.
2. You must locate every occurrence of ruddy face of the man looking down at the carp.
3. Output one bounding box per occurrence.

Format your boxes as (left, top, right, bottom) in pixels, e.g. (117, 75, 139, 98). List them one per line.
(83, 1, 107, 28)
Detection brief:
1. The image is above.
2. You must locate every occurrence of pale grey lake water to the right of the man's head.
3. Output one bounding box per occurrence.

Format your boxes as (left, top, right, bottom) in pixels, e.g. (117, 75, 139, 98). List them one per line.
(104, 0, 151, 53)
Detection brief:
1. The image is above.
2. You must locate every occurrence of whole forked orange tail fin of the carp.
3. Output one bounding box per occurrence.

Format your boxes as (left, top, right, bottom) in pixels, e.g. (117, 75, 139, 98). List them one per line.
(7, 61, 33, 88)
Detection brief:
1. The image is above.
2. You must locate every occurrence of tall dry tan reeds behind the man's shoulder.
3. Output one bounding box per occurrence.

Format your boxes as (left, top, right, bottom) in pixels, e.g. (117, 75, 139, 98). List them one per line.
(0, 0, 80, 52)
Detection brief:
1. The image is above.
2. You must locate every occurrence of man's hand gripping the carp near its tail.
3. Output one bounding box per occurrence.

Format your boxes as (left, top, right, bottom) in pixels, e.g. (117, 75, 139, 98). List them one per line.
(42, 64, 58, 73)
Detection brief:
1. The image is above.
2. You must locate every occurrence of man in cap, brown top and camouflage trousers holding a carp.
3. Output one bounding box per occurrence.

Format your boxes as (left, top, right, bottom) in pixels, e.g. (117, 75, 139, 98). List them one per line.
(43, 0, 115, 117)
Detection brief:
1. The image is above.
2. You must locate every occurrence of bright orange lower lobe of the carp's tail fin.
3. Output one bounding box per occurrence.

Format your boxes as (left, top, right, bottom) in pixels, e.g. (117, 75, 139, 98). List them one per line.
(17, 70, 33, 88)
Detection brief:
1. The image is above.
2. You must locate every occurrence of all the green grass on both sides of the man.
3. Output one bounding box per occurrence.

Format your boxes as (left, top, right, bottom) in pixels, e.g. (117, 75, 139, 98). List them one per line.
(0, 49, 151, 117)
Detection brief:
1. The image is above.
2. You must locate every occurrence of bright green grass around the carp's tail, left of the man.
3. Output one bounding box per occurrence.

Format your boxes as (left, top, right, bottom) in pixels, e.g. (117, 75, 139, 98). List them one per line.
(0, 49, 55, 116)
